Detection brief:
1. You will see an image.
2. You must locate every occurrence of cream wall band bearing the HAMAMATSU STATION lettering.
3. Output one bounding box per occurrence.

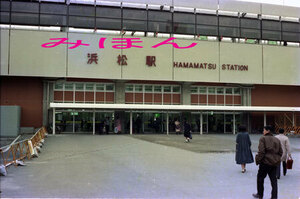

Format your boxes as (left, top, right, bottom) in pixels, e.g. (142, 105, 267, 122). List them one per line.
(1, 30, 300, 85)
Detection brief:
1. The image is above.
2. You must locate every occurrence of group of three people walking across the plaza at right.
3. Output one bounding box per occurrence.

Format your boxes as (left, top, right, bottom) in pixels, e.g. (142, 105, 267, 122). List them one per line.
(235, 126, 292, 199)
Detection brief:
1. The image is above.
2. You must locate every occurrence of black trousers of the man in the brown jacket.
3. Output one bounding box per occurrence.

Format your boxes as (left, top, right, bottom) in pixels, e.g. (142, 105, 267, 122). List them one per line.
(257, 164, 277, 198)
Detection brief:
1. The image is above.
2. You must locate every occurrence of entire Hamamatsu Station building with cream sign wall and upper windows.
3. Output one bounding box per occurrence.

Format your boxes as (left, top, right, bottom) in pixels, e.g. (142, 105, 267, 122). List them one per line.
(0, 0, 300, 134)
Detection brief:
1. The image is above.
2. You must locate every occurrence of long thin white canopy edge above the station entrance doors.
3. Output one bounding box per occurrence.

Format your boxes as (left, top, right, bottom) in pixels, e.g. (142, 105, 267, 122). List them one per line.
(50, 103, 300, 112)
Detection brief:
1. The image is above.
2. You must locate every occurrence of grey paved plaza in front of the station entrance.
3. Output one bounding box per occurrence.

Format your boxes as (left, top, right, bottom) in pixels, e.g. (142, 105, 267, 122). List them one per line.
(1, 135, 300, 199)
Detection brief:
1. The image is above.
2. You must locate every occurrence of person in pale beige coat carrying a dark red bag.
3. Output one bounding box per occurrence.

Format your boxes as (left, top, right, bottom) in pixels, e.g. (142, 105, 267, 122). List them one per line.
(275, 129, 292, 179)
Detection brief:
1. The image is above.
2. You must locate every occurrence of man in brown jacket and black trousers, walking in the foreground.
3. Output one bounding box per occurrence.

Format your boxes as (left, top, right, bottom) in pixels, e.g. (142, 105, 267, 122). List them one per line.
(253, 126, 282, 199)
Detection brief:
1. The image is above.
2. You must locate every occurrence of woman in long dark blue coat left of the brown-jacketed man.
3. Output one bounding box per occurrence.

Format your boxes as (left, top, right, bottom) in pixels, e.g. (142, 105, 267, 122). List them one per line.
(235, 125, 254, 173)
